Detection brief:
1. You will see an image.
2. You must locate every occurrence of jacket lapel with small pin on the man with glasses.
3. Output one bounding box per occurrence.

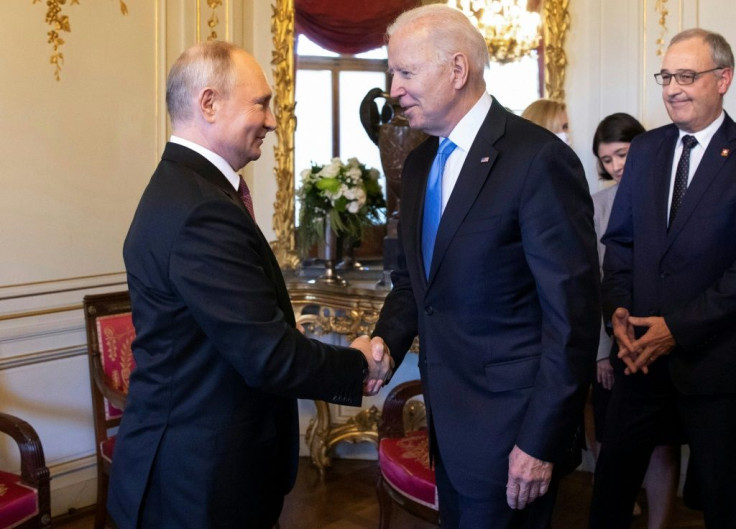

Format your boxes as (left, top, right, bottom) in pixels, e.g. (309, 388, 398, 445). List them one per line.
(667, 115, 736, 247)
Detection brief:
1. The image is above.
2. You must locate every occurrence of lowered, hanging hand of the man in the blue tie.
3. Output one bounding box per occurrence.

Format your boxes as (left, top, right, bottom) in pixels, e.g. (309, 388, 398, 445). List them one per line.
(506, 445, 554, 509)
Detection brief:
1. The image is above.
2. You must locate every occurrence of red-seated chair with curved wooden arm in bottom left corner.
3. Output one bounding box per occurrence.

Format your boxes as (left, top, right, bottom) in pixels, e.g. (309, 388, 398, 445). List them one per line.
(0, 413, 51, 529)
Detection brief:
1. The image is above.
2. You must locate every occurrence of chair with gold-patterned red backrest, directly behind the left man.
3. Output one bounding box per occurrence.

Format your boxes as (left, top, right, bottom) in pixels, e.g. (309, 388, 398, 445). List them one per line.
(84, 292, 135, 529)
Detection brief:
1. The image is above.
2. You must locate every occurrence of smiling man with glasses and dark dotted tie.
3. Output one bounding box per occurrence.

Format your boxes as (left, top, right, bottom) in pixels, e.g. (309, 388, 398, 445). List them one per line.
(591, 29, 736, 529)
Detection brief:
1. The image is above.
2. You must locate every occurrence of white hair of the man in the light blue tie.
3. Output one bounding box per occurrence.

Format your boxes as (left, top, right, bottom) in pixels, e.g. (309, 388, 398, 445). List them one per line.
(386, 4, 490, 76)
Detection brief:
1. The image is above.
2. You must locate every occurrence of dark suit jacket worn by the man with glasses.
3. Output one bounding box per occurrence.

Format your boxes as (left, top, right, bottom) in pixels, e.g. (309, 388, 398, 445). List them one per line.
(603, 115, 736, 395)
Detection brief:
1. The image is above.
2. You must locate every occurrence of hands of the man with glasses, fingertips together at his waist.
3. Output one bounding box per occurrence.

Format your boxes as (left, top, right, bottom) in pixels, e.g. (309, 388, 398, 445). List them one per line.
(611, 307, 675, 375)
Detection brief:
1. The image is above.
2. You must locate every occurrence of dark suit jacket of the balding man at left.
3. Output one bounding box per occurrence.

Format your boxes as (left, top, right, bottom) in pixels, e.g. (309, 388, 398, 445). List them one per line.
(108, 143, 363, 529)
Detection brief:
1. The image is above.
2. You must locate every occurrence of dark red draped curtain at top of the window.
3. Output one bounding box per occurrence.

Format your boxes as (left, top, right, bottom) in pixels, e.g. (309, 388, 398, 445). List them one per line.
(294, 0, 421, 54)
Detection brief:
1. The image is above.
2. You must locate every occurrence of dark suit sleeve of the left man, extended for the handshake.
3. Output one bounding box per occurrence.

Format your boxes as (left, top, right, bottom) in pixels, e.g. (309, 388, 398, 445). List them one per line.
(169, 200, 363, 405)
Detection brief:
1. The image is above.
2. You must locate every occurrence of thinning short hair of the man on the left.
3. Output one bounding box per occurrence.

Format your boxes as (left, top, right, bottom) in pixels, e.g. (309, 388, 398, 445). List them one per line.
(166, 41, 239, 124)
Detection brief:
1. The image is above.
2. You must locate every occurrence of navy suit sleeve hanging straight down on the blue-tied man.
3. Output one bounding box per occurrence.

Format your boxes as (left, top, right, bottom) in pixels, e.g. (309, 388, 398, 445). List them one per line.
(516, 142, 601, 461)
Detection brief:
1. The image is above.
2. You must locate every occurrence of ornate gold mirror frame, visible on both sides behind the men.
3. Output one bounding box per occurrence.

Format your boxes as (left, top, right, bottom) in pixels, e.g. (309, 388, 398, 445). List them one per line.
(271, 0, 570, 269)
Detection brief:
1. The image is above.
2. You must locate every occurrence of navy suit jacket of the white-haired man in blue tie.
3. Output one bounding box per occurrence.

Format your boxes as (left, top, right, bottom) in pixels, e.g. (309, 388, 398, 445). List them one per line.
(375, 100, 600, 498)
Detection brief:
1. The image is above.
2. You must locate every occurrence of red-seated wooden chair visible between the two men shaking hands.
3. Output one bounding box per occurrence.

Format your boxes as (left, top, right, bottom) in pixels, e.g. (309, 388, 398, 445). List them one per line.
(376, 380, 439, 529)
